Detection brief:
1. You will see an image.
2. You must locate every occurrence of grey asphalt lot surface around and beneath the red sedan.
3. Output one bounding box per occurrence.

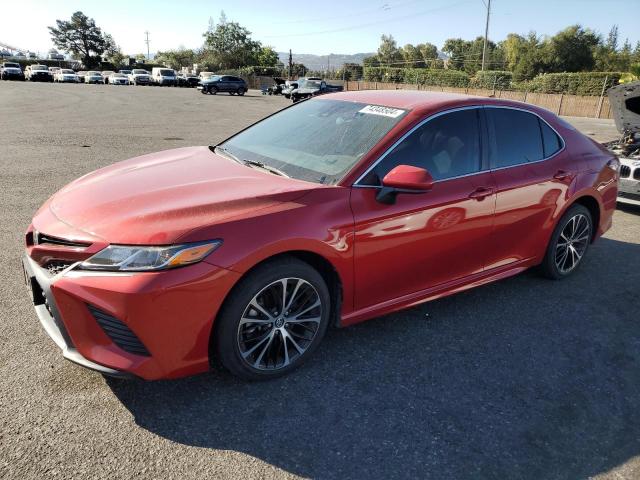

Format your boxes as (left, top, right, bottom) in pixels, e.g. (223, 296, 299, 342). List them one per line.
(0, 82, 640, 479)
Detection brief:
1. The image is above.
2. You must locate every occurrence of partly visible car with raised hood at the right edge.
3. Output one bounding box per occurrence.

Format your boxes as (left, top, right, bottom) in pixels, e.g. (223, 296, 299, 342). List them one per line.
(606, 81, 640, 206)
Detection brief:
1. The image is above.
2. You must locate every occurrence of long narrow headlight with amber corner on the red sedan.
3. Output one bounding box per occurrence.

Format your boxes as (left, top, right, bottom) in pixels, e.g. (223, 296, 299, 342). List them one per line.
(78, 240, 222, 272)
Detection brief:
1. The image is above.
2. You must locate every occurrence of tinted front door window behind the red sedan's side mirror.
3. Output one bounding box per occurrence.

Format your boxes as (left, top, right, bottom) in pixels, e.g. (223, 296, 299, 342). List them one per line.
(359, 108, 481, 185)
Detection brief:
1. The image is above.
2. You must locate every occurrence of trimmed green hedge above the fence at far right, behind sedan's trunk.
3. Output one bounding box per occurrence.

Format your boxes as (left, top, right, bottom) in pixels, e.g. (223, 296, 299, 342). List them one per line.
(528, 72, 622, 95)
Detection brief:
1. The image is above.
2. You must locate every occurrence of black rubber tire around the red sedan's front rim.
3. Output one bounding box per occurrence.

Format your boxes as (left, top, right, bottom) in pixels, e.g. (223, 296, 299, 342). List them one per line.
(216, 257, 331, 380)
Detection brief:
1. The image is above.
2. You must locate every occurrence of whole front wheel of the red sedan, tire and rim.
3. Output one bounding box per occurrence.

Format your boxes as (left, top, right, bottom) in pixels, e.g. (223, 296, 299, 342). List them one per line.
(218, 258, 331, 380)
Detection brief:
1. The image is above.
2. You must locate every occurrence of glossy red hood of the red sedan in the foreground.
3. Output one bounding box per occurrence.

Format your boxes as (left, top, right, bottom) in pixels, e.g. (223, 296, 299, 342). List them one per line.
(33, 147, 322, 244)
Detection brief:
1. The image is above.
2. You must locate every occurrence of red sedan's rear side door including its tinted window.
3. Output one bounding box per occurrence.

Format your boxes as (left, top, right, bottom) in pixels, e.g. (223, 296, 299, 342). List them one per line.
(485, 106, 578, 268)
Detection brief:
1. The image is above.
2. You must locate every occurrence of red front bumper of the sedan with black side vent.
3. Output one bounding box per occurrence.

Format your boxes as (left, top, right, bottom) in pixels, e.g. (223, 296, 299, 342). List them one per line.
(23, 254, 239, 380)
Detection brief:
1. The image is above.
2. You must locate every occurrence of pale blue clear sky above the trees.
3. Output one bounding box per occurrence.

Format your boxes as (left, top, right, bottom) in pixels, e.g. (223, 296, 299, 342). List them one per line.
(0, 0, 640, 55)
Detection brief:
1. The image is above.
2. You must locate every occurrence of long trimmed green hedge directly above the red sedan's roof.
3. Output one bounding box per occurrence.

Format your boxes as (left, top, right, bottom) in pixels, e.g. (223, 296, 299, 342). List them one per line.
(364, 67, 469, 88)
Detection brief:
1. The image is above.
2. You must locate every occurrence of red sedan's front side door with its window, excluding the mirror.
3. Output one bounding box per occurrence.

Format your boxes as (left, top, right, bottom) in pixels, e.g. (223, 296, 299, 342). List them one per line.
(351, 107, 495, 309)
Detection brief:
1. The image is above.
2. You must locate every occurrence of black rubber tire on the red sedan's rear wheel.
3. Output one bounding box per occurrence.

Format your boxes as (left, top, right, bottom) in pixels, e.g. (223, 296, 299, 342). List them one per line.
(540, 204, 594, 280)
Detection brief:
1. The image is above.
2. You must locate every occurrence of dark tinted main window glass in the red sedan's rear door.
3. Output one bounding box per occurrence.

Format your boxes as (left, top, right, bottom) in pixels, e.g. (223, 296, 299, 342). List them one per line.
(486, 108, 545, 168)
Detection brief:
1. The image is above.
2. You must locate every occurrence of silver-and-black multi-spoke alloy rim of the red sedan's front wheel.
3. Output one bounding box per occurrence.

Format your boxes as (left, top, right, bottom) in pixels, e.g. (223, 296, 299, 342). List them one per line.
(237, 278, 322, 371)
